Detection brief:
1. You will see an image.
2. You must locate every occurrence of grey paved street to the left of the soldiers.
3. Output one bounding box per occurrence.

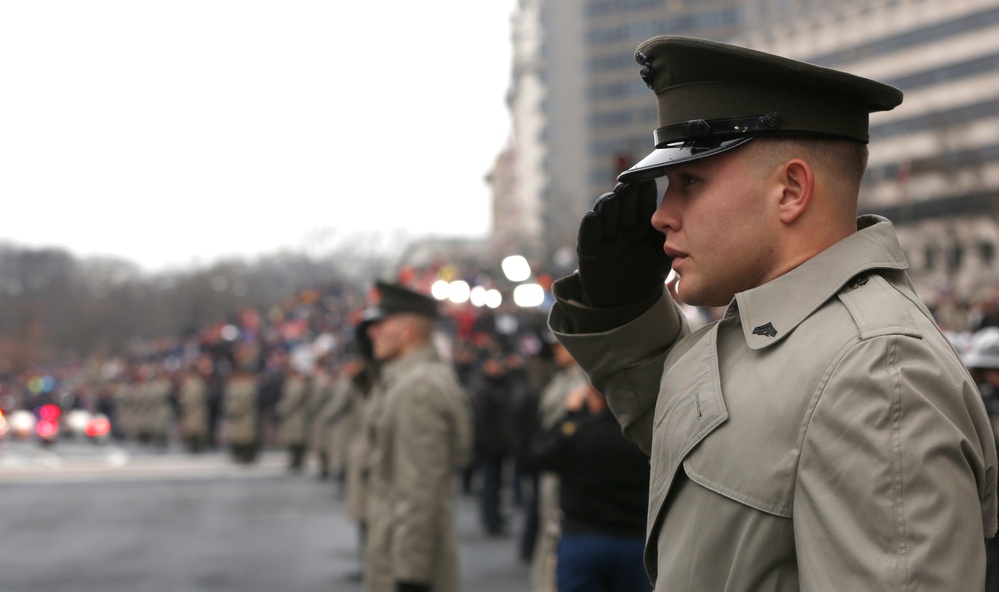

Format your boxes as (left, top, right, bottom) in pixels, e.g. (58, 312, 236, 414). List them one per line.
(0, 442, 529, 592)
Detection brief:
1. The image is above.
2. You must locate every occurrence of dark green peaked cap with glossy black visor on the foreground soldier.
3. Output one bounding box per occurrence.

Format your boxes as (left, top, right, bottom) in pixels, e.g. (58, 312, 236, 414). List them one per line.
(618, 35, 902, 182)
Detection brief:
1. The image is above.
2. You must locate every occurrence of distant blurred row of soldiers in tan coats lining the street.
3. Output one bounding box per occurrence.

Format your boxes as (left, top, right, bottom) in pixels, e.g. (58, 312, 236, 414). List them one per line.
(105, 347, 365, 470)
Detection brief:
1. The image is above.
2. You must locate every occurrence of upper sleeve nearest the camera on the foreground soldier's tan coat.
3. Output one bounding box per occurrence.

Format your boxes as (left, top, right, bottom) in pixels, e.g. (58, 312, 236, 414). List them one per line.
(794, 335, 996, 591)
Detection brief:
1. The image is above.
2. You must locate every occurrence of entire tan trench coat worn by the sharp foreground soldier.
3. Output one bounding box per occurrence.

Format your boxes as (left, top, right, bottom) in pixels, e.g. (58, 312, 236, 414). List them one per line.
(549, 217, 996, 592)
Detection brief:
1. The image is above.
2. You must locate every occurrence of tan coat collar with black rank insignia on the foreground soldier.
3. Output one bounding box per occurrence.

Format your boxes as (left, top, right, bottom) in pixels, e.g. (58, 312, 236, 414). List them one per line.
(725, 215, 908, 350)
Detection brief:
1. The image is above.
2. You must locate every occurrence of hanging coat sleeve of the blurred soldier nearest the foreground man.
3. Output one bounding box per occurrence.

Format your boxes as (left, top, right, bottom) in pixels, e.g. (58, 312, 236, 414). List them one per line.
(391, 380, 467, 583)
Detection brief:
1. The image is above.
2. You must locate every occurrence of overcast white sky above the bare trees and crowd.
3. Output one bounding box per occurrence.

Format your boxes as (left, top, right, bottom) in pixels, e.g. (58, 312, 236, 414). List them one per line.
(0, 0, 516, 271)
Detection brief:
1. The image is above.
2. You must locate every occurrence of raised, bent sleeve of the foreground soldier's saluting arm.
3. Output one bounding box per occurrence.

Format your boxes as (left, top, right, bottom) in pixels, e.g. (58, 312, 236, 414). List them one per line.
(548, 278, 690, 454)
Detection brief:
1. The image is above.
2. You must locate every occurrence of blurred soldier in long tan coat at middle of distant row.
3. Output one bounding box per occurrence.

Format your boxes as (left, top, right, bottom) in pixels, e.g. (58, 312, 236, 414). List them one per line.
(222, 345, 260, 463)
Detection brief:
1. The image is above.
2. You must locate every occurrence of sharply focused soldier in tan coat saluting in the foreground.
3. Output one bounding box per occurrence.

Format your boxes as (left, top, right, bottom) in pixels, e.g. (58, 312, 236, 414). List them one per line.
(549, 36, 997, 592)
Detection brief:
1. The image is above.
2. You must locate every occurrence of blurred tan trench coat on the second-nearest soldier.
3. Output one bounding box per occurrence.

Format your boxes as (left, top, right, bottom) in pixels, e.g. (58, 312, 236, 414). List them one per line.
(364, 345, 472, 592)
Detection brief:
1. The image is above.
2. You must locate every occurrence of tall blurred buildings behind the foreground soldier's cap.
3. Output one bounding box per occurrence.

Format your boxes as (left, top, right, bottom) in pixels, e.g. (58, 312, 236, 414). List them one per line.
(489, 0, 999, 303)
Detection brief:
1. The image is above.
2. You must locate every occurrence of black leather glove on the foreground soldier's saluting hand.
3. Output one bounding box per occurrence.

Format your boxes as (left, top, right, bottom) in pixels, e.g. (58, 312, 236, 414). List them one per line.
(576, 180, 672, 307)
